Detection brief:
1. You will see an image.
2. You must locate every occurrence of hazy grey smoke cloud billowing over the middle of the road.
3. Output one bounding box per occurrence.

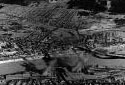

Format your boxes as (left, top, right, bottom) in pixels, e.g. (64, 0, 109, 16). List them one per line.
(44, 49, 89, 75)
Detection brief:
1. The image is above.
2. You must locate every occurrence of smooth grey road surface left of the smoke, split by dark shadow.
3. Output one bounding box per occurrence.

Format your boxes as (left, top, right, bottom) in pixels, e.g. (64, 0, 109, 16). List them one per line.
(0, 59, 46, 75)
